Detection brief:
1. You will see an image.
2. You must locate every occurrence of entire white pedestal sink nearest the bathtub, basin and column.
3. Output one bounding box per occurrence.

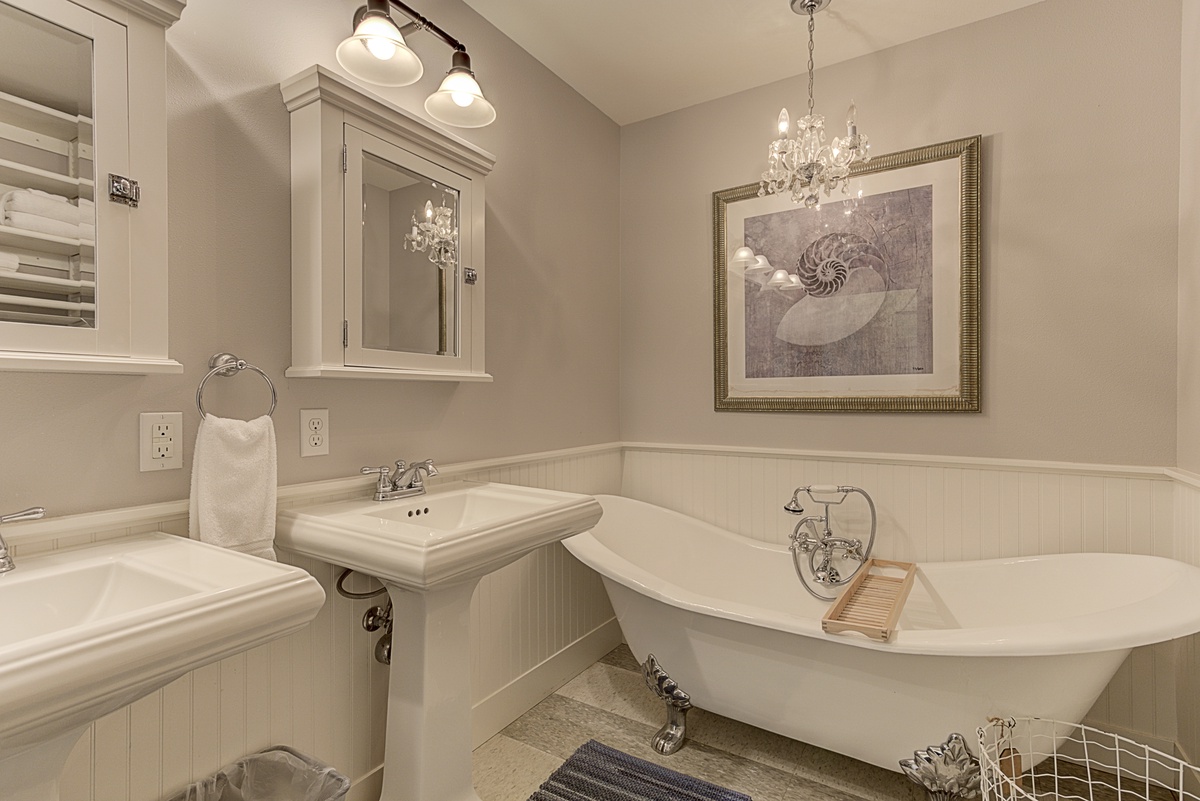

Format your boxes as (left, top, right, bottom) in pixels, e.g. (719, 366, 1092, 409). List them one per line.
(276, 482, 601, 801)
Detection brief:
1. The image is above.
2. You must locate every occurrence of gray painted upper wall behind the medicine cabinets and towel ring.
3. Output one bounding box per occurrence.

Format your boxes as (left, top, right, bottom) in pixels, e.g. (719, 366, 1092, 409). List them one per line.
(0, 0, 619, 516)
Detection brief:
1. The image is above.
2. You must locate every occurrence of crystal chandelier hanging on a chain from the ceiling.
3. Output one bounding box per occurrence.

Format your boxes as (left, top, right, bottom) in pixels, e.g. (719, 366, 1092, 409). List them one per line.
(758, 0, 871, 209)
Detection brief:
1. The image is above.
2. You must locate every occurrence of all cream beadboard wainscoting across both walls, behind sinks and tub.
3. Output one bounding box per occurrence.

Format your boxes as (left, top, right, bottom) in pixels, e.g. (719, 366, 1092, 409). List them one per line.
(6, 444, 1200, 801)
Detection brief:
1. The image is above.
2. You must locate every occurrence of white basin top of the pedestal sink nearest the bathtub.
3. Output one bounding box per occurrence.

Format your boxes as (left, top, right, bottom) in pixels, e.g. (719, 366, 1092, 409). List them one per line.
(276, 481, 600, 591)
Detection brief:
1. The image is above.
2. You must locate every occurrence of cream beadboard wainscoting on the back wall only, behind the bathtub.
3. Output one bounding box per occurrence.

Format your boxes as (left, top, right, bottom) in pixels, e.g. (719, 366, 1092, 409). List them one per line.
(622, 444, 1176, 751)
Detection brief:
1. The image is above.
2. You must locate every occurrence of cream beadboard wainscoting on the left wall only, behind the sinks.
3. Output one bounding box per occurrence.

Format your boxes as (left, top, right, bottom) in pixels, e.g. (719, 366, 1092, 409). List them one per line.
(8, 444, 620, 801)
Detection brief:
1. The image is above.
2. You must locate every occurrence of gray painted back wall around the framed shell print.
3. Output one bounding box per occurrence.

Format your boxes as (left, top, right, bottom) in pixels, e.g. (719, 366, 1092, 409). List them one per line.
(620, 0, 1181, 465)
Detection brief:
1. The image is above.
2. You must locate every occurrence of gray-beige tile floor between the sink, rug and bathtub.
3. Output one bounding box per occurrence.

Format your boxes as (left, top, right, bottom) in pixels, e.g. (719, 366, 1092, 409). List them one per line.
(474, 645, 925, 801)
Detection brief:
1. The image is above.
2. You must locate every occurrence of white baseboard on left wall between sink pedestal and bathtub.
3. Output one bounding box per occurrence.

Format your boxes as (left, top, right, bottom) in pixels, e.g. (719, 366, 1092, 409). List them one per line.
(470, 618, 622, 748)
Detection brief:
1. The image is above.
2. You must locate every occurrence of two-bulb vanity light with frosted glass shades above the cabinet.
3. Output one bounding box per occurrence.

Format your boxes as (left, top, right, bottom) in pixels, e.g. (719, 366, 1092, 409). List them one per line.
(337, 0, 496, 128)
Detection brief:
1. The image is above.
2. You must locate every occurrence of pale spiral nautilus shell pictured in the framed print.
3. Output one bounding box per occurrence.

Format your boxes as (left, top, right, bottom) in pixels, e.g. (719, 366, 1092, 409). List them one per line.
(775, 231, 913, 345)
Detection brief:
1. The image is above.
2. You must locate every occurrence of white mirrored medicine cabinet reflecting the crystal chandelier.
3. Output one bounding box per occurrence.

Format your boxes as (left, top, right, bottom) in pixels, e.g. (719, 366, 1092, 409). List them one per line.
(280, 65, 496, 381)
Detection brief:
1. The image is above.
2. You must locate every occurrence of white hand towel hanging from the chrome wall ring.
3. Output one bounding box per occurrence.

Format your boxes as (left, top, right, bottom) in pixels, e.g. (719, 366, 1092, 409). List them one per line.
(188, 415, 278, 561)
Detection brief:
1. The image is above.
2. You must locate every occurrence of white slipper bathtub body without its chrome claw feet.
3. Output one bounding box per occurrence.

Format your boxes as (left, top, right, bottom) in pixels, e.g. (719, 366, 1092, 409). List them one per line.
(565, 496, 1200, 770)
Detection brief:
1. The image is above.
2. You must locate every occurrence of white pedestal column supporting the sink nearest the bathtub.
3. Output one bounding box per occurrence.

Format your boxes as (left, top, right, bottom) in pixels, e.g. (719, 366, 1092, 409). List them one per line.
(379, 578, 479, 801)
